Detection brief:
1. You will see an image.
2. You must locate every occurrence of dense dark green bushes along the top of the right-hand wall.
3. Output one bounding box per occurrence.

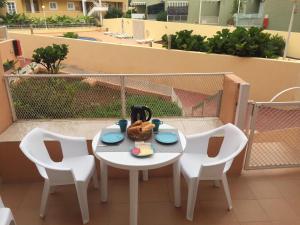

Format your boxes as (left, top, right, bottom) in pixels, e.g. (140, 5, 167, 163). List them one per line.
(162, 27, 285, 58)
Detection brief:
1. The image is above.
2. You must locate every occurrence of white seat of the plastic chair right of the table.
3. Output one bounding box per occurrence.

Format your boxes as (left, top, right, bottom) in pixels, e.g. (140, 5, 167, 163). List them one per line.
(180, 153, 217, 178)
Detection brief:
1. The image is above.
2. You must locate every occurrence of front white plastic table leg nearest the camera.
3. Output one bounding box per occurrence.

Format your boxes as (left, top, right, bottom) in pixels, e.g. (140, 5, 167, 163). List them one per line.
(129, 170, 139, 225)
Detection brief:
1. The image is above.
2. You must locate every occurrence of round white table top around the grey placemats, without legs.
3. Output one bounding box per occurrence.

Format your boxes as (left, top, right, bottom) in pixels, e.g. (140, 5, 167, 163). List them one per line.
(92, 124, 186, 170)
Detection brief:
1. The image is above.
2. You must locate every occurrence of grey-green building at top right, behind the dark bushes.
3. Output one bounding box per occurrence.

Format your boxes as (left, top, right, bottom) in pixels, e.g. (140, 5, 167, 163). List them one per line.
(131, 0, 300, 32)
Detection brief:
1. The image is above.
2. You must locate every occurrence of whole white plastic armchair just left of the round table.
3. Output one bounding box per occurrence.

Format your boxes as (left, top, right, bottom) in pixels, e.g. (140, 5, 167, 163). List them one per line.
(20, 128, 98, 224)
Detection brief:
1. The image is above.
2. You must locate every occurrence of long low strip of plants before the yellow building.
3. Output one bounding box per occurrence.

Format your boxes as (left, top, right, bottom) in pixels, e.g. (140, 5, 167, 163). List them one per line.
(0, 13, 95, 26)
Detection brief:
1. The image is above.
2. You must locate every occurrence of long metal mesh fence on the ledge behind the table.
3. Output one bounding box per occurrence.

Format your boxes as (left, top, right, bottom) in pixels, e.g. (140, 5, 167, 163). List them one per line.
(5, 74, 224, 119)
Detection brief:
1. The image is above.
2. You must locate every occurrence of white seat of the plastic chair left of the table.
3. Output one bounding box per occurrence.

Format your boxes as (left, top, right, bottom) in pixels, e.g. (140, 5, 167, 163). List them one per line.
(60, 155, 95, 181)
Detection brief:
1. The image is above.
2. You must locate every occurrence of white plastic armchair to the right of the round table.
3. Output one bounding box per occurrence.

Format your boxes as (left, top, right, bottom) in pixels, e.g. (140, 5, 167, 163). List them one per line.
(180, 124, 248, 220)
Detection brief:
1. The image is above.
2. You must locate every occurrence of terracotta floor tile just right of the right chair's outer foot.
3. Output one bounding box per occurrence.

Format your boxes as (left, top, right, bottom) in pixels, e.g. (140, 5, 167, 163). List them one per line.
(233, 200, 268, 222)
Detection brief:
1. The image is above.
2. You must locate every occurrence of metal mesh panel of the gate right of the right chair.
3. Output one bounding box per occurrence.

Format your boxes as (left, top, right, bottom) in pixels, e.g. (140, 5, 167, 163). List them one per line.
(246, 102, 300, 169)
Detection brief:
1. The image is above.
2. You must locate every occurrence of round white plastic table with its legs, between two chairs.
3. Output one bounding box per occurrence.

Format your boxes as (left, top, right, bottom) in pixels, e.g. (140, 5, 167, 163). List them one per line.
(92, 124, 186, 225)
